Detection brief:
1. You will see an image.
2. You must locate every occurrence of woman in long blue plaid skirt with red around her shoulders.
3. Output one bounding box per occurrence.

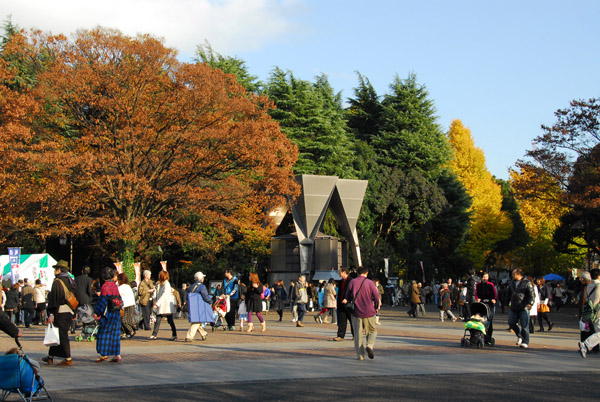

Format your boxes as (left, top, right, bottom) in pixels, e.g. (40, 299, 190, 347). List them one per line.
(94, 267, 123, 363)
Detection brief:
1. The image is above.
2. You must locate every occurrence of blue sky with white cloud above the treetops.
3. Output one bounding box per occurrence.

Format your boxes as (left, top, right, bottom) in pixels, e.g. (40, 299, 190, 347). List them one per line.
(0, 0, 600, 179)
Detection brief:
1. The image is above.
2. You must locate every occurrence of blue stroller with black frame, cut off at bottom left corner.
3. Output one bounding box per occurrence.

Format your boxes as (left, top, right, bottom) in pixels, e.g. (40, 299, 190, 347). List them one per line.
(0, 340, 52, 401)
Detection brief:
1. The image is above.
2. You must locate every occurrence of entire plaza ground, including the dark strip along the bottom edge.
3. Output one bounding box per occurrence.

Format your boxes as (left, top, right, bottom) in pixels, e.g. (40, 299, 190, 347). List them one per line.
(0, 305, 600, 401)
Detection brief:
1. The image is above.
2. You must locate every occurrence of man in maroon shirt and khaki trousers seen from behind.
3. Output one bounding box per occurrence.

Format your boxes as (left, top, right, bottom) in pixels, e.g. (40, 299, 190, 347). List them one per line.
(342, 267, 381, 360)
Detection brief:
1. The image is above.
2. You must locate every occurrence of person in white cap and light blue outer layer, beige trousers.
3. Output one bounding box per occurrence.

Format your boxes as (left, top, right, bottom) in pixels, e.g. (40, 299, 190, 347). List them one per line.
(185, 271, 214, 342)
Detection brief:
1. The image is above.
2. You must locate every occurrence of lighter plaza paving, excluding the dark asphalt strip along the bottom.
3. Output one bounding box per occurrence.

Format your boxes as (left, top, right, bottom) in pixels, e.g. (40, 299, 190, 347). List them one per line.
(0, 306, 600, 398)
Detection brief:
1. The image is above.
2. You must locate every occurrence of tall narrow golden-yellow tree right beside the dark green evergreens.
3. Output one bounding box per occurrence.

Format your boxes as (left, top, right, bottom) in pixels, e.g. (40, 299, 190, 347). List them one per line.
(448, 120, 513, 267)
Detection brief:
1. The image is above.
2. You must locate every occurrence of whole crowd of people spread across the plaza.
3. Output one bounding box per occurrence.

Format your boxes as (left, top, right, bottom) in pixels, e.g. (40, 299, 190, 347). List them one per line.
(0, 260, 600, 366)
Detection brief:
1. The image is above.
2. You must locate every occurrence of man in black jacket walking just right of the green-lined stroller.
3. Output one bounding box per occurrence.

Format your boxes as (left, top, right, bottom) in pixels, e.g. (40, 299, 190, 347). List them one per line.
(508, 268, 535, 348)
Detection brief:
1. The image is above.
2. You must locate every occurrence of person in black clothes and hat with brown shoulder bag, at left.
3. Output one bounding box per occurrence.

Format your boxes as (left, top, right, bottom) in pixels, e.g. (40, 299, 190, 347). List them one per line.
(42, 260, 75, 366)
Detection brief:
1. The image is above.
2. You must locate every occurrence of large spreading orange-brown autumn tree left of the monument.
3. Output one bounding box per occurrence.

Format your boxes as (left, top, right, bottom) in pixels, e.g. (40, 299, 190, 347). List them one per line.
(2, 28, 297, 280)
